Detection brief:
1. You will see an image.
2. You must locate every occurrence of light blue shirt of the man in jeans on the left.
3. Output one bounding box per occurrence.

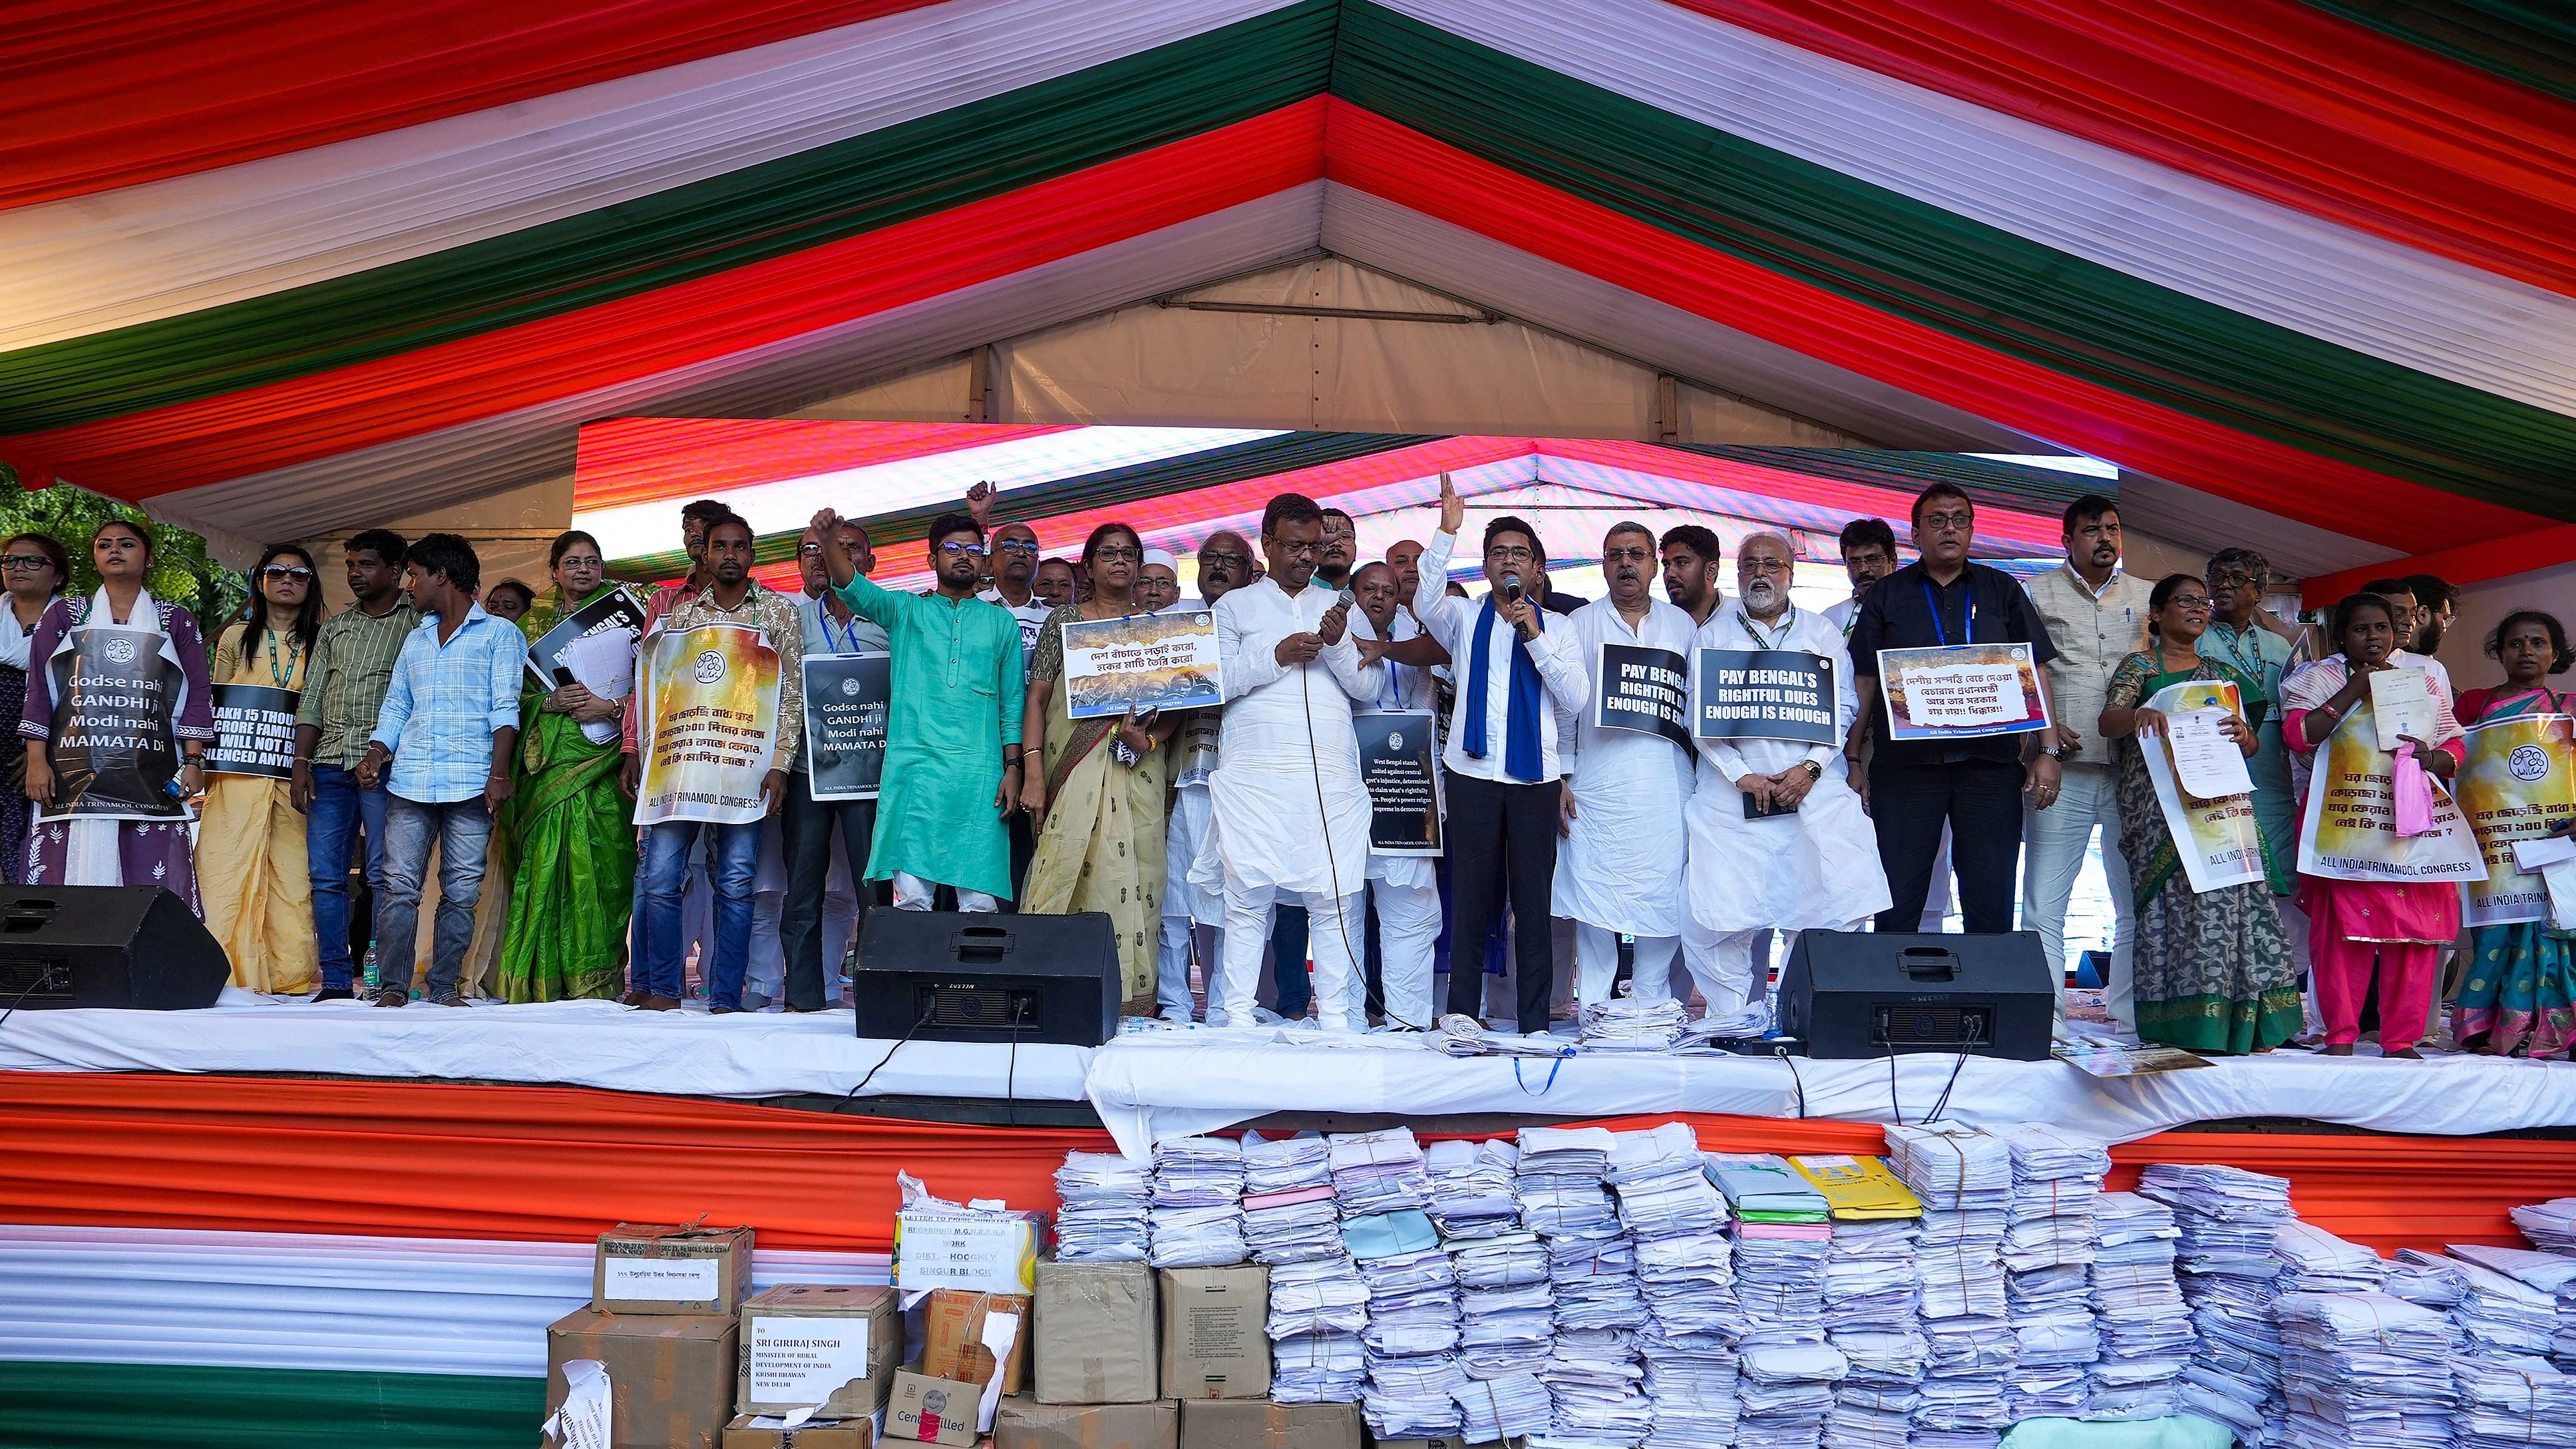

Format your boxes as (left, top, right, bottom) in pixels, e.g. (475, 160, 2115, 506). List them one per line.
(373, 603, 528, 805)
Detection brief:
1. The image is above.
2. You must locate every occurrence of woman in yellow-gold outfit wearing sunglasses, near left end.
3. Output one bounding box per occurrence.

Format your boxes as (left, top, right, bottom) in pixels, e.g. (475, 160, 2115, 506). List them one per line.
(196, 544, 322, 992)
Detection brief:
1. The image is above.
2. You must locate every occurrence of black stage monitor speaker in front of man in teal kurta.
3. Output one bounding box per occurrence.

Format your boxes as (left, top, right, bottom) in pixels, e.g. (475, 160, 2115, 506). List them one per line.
(850, 910, 1121, 1047)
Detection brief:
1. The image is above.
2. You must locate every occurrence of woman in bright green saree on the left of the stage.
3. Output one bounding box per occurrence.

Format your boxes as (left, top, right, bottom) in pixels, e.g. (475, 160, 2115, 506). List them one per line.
(500, 531, 636, 1000)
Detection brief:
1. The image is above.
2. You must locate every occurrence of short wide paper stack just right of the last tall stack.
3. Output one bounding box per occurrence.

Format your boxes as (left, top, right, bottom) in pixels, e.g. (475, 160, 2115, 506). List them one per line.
(2272, 1292, 2455, 1449)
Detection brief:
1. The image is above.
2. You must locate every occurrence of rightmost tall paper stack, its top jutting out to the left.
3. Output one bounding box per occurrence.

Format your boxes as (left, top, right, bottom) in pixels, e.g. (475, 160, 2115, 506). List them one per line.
(2138, 1163, 2293, 1444)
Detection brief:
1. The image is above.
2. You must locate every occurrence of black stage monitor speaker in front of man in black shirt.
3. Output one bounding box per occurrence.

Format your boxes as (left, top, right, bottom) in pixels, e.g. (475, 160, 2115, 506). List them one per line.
(1780, 931, 2058, 1062)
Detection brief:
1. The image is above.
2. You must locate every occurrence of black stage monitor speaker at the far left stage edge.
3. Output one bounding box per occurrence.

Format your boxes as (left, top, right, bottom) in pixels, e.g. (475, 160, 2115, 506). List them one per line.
(0, 885, 232, 1010)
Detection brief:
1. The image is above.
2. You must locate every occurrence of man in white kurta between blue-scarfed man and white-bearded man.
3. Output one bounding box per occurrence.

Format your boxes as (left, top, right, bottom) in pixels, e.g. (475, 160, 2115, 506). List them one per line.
(1556, 523, 1698, 1006)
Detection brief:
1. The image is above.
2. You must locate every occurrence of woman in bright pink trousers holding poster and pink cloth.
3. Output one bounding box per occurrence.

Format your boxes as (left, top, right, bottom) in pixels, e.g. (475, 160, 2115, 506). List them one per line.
(2280, 593, 2466, 1060)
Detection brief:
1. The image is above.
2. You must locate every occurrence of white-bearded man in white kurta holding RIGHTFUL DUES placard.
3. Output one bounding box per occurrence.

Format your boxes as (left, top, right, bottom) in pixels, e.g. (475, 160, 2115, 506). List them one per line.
(1685, 534, 1888, 1016)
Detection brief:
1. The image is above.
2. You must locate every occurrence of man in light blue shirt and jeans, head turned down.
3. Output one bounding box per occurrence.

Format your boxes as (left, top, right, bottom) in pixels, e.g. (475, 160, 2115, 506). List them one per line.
(358, 534, 528, 1006)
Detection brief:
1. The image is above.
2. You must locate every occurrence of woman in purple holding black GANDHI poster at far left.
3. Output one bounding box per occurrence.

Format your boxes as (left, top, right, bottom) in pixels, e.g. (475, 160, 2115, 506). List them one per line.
(18, 518, 214, 897)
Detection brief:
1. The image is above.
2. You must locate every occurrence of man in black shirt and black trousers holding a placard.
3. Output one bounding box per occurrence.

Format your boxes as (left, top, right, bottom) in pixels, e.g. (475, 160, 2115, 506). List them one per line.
(1845, 482, 2058, 933)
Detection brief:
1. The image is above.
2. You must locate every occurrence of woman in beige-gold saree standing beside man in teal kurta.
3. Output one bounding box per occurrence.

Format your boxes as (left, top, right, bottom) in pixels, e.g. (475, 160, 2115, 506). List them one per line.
(1020, 523, 1180, 1016)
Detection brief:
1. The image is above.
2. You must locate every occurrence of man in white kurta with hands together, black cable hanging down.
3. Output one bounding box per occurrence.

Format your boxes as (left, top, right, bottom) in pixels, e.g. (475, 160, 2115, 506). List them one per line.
(1195, 493, 1386, 1031)
